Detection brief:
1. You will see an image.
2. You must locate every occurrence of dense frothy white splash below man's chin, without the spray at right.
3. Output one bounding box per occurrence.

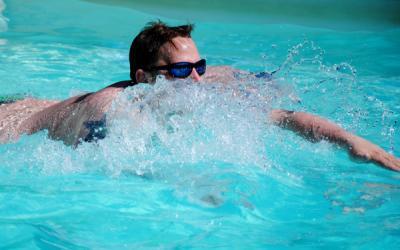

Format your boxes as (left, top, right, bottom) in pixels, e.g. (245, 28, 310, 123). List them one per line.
(1, 79, 290, 207)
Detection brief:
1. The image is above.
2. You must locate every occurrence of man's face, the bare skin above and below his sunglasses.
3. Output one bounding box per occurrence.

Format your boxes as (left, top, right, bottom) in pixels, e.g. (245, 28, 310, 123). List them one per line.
(138, 37, 201, 82)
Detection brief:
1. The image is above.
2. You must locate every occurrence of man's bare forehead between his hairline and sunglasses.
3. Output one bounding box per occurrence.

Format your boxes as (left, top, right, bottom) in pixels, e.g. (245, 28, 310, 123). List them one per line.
(159, 37, 200, 63)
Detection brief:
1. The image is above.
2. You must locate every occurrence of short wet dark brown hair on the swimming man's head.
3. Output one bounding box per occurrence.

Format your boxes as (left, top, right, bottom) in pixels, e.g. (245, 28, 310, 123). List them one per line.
(129, 21, 194, 83)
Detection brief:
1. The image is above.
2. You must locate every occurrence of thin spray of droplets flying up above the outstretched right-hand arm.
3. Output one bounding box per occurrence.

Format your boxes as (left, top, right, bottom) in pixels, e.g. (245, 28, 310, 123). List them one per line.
(275, 39, 366, 131)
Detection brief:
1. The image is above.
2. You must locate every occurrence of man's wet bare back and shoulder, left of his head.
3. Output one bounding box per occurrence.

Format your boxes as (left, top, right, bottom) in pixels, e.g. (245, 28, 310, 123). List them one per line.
(0, 81, 131, 145)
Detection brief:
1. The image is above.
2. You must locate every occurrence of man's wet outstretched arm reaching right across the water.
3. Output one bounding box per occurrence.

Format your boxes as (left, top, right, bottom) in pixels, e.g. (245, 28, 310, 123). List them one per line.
(270, 110, 400, 171)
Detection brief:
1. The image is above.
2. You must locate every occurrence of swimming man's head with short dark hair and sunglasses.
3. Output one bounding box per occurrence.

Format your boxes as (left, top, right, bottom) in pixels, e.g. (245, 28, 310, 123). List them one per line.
(129, 21, 205, 83)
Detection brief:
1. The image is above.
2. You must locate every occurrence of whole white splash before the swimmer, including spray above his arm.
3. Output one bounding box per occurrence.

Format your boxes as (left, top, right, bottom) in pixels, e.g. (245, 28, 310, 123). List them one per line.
(0, 41, 372, 178)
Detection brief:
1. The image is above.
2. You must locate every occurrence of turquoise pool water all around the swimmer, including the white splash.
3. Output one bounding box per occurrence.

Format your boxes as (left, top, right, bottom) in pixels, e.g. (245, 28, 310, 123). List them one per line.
(0, 0, 400, 249)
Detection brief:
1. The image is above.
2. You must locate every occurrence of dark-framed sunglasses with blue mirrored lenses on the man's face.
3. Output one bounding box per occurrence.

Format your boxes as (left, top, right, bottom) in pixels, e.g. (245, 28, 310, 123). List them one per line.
(151, 59, 206, 78)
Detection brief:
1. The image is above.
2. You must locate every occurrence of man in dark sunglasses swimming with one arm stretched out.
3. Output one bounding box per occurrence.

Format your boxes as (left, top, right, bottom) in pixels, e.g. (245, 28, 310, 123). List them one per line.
(0, 22, 400, 171)
